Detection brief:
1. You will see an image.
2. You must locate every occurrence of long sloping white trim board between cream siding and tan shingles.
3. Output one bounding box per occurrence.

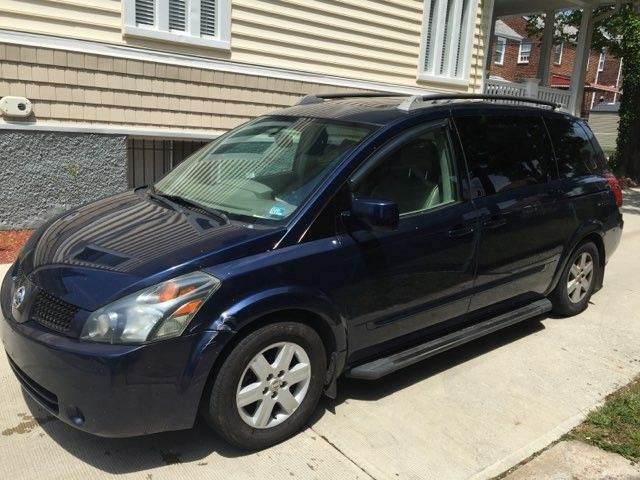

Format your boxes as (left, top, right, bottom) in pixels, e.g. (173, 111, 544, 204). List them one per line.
(0, 29, 440, 95)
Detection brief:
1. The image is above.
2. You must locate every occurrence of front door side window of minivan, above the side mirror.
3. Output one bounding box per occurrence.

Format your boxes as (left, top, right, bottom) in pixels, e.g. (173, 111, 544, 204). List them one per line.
(354, 127, 458, 215)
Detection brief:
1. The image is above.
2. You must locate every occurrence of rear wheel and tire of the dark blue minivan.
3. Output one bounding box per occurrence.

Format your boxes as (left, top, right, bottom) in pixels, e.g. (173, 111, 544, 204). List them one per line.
(549, 242, 601, 317)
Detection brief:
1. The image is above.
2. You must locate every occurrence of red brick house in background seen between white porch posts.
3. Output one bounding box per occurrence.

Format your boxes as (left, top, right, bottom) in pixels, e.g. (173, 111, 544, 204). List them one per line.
(490, 15, 622, 116)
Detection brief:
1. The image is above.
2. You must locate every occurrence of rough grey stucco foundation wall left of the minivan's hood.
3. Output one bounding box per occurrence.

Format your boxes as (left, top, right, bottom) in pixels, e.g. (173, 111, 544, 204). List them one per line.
(0, 130, 127, 230)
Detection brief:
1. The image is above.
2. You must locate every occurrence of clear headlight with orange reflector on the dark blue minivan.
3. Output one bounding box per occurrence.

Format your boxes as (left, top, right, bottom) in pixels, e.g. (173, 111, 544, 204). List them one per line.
(81, 272, 220, 344)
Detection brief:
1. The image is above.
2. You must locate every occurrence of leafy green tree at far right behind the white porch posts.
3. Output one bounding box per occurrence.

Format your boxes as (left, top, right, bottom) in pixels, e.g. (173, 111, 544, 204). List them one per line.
(527, 4, 640, 180)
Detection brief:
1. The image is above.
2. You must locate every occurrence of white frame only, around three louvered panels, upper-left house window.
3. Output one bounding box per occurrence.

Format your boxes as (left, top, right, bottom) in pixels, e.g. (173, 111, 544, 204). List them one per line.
(122, 0, 231, 50)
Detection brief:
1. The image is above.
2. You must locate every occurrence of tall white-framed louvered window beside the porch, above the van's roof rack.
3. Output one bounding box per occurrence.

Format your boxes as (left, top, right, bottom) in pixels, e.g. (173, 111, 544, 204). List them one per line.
(420, 0, 478, 80)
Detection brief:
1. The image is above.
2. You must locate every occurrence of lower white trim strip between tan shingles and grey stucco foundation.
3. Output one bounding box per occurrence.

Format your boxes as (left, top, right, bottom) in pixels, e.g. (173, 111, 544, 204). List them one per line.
(0, 120, 225, 140)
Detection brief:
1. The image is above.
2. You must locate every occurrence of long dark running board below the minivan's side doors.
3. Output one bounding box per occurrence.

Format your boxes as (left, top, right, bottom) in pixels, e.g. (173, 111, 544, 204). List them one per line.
(346, 298, 551, 380)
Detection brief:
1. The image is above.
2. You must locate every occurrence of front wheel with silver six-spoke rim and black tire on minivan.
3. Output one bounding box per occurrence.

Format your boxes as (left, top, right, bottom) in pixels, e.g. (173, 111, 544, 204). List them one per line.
(202, 321, 327, 450)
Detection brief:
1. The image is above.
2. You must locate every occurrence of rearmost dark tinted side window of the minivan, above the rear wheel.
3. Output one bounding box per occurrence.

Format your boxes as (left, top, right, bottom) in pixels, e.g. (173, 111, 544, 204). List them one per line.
(546, 117, 604, 178)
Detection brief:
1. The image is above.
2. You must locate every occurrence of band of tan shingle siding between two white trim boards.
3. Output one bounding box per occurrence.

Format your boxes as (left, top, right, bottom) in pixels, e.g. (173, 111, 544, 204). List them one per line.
(0, 43, 368, 133)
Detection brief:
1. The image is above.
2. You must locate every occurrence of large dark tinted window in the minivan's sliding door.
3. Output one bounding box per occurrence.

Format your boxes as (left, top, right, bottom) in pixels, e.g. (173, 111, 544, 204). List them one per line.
(456, 115, 552, 196)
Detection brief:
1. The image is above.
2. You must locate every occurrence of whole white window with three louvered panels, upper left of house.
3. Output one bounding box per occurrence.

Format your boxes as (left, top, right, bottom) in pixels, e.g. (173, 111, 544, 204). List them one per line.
(122, 0, 231, 48)
